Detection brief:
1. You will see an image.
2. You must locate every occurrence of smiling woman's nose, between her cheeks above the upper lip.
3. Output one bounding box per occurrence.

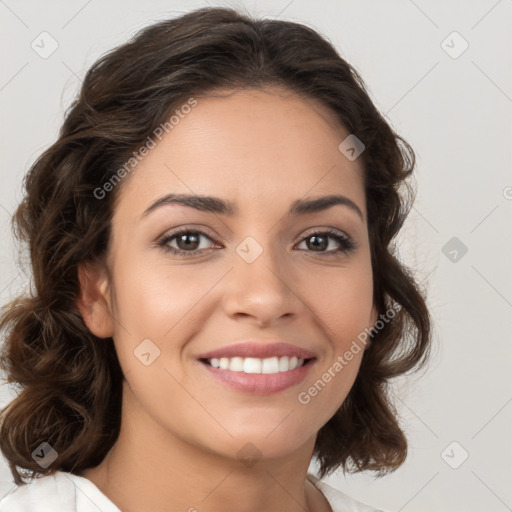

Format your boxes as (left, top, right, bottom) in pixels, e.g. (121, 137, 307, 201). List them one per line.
(223, 239, 305, 327)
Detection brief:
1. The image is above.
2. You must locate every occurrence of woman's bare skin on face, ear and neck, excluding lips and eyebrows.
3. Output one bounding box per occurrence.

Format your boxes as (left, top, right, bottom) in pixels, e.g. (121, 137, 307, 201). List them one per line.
(77, 88, 377, 512)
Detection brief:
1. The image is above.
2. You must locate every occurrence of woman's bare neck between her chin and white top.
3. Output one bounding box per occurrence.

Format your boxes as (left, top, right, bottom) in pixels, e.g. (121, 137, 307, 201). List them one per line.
(81, 382, 331, 512)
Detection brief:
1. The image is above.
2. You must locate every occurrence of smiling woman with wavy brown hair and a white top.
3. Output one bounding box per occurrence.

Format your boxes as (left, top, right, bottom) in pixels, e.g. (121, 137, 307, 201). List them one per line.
(0, 8, 430, 512)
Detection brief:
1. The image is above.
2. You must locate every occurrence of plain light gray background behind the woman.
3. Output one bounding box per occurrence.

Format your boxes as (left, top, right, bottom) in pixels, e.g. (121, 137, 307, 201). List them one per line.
(0, 0, 512, 512)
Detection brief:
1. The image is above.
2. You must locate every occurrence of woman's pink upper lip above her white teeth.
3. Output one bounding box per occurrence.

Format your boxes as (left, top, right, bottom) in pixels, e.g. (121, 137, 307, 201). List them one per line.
(198, 340, 315, 359)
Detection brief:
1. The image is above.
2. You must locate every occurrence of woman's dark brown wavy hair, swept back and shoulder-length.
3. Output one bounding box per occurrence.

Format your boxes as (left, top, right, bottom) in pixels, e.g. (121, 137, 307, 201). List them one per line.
(0, 8, 431, 485)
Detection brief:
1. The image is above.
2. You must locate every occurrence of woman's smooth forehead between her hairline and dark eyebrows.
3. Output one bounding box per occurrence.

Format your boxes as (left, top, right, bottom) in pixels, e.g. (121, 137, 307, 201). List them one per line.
(116, 88, 365, 220)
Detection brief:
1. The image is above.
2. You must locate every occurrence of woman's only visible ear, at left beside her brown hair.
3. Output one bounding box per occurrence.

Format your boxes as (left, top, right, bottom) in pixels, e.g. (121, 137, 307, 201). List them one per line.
(76, 262, 114, 338)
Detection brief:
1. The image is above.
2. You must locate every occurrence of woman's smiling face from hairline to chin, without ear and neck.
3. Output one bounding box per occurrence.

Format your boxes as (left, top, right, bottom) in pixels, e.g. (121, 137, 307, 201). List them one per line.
(89, 89, 377, 464)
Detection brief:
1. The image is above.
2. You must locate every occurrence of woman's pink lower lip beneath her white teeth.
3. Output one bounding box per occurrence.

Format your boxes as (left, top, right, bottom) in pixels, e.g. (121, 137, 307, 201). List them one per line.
(199, 359, 315, 395)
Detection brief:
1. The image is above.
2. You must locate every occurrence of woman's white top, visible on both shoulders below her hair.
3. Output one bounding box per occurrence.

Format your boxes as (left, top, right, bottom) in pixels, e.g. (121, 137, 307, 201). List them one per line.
(0, 471, 383, 512)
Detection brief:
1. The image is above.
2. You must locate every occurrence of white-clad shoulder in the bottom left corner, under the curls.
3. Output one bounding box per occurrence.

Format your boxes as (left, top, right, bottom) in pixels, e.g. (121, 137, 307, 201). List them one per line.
(0, 471, 120, 512)
